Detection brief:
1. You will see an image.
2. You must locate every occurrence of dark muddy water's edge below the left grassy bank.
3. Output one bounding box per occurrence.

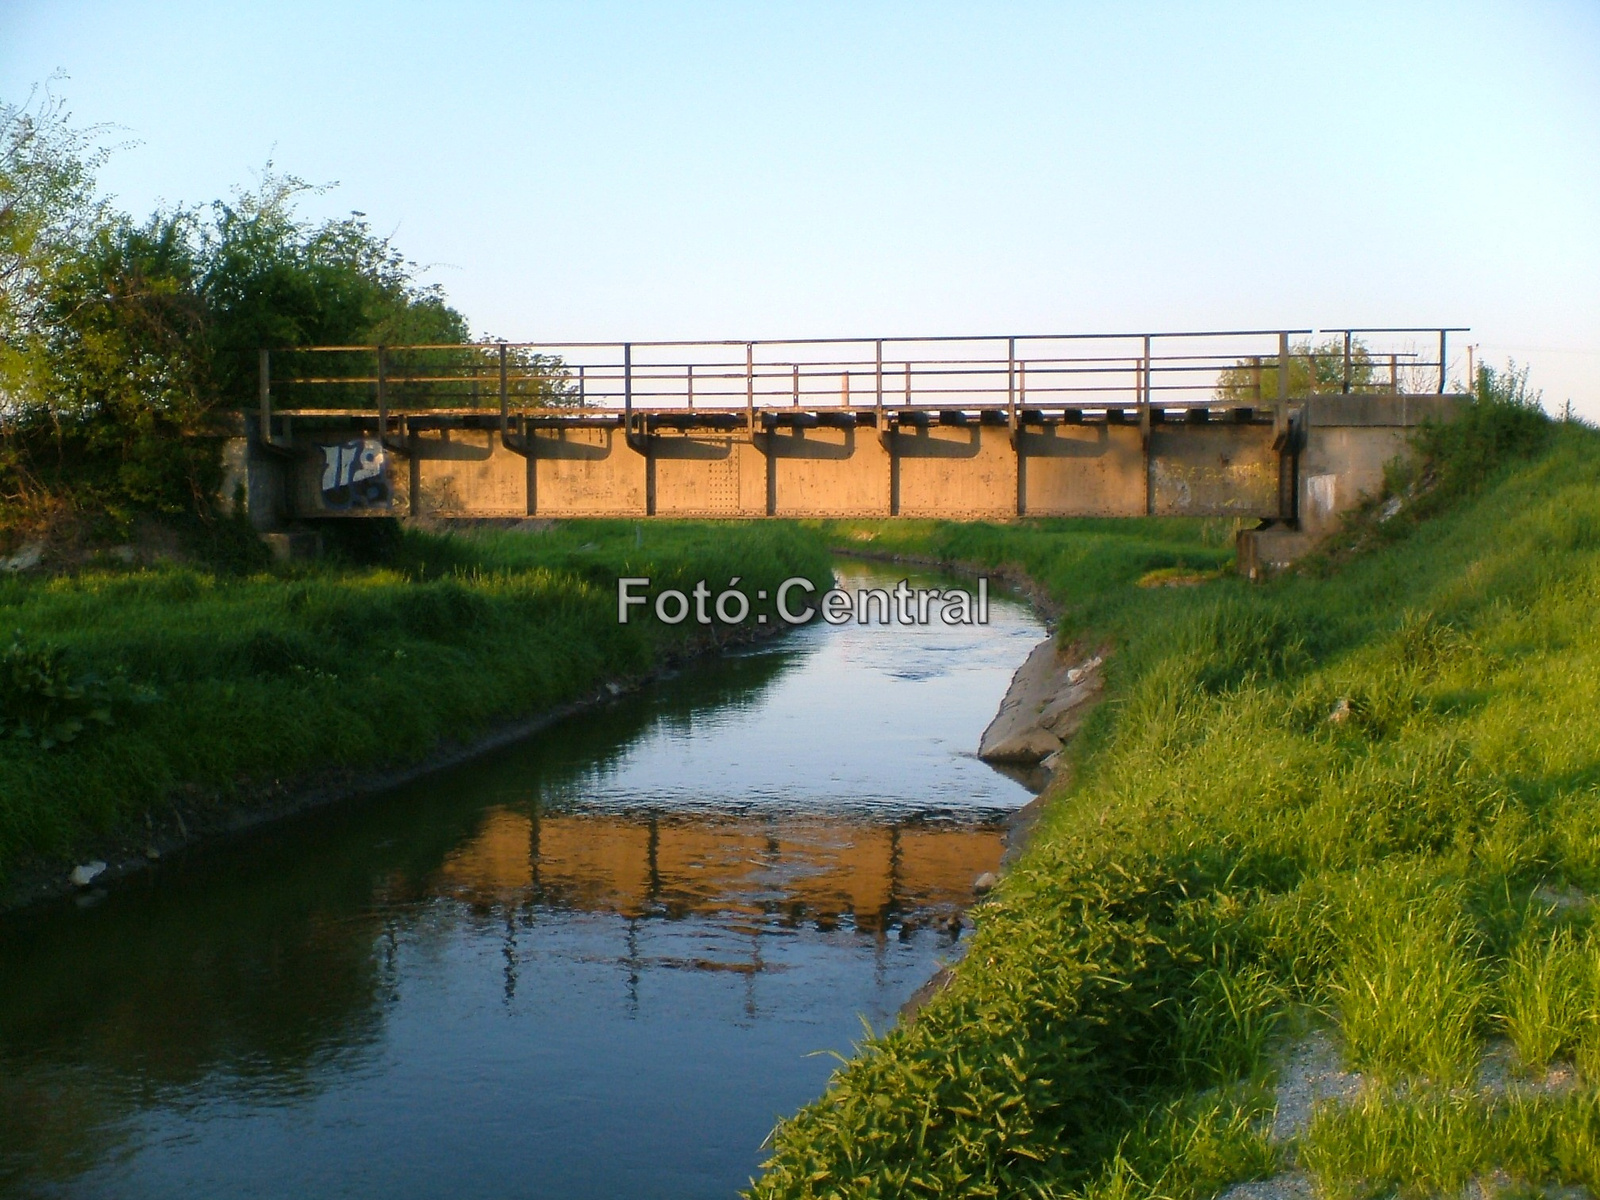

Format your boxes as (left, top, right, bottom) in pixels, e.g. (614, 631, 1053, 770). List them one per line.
(0, 624, 787, 917)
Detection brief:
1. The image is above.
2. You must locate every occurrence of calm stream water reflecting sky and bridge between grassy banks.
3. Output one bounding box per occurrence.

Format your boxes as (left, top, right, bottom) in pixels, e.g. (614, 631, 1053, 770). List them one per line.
(0, 566, 1042, 1200)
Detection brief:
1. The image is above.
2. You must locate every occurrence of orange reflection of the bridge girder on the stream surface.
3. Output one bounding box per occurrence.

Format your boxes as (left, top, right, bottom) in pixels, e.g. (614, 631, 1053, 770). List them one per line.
(434, 808, 1005, 933)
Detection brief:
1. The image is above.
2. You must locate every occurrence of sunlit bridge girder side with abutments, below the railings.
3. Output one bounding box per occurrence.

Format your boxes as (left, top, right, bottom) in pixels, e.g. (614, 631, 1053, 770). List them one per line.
(226, 395, 1459, 533)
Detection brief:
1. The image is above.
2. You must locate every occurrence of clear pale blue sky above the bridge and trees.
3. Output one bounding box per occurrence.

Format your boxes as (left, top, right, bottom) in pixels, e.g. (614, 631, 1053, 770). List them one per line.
(9, 0, 1600, 418)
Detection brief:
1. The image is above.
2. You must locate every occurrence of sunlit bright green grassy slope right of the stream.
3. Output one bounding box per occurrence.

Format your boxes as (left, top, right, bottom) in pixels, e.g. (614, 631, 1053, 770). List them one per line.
(754, 413, 1600, 1198)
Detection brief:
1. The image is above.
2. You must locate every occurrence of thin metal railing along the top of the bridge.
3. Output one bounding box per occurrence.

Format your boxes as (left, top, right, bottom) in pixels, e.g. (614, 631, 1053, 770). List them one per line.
(259, 326, 1464, 438)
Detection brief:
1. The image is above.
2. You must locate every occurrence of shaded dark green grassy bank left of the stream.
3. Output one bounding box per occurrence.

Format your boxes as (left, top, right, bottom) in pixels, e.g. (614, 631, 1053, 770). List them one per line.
(0, 522, 829, 889)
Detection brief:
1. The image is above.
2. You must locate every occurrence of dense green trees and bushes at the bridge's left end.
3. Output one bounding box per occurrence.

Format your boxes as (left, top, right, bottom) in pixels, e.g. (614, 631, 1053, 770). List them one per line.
(0, 85, 570, 546)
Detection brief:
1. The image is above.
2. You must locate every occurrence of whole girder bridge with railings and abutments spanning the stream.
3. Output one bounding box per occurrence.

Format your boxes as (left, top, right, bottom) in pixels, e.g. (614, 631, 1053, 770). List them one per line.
(224, 328, 1461, 531)
